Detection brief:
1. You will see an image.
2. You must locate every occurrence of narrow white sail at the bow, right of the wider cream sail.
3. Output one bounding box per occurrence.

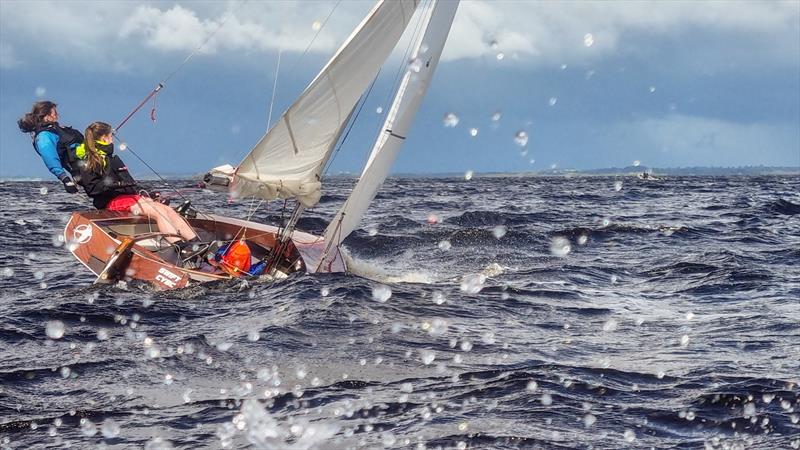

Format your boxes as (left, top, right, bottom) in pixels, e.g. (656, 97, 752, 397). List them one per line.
(320, 0, 458, 270)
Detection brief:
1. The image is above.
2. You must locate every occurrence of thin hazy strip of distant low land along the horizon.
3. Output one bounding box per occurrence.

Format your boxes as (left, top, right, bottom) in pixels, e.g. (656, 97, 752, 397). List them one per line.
(0, 166, 800, 182)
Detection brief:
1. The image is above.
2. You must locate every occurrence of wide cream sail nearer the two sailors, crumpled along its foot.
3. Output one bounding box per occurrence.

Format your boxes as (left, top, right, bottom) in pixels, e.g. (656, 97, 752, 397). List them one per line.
(231, 0, 419, 207)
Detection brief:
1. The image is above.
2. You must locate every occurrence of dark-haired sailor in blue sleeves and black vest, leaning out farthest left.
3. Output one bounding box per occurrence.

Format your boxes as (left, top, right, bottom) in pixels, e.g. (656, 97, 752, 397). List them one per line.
(17, 101, 83, 194)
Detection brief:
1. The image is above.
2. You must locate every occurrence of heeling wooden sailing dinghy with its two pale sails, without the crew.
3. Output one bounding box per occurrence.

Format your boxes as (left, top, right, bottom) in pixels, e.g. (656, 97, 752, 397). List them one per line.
(64, 0, 458, 289)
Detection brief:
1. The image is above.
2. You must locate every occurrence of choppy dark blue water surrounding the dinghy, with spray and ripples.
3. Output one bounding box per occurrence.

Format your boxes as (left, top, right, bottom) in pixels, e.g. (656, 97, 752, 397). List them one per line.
(0, 176, 800, 449)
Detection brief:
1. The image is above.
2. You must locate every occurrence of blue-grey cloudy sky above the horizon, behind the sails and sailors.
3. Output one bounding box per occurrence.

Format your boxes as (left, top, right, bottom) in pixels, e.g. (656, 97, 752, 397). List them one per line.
(0, 0, 800, 178)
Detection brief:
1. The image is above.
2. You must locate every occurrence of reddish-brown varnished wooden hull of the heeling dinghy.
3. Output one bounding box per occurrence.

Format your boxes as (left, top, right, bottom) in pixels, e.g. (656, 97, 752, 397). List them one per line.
(64, 210, 346, 289)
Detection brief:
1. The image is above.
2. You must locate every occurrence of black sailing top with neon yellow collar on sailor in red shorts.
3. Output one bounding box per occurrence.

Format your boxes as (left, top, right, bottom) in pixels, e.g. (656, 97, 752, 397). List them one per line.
(75, 141, 138, 209)
